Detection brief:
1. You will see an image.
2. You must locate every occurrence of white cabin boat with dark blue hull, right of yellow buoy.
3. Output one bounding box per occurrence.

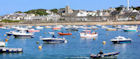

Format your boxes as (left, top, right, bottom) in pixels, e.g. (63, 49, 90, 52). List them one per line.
(111, 36, 132, 43)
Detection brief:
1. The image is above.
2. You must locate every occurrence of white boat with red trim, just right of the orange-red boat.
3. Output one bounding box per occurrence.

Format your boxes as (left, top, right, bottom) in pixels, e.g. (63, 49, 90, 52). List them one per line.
(80, 30, 98, 38)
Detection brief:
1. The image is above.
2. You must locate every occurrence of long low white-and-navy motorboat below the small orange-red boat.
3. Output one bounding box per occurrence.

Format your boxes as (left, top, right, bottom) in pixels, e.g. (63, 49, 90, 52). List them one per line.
(41, 38, 67, 44)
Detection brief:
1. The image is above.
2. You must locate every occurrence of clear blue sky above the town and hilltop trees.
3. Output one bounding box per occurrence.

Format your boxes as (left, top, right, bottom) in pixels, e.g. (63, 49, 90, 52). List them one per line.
(0, 0, 140, 16)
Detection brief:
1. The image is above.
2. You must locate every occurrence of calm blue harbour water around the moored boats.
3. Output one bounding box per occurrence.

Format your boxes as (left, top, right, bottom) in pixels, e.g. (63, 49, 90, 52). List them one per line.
(0, 26, 140, 59)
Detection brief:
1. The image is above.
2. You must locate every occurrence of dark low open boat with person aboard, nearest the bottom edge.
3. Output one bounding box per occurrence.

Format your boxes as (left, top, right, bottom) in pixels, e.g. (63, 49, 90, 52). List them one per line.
(90, 52, 120, 59)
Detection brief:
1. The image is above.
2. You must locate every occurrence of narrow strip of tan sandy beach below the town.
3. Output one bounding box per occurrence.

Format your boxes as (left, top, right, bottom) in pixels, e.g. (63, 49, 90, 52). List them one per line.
(0, 21, 140, 26)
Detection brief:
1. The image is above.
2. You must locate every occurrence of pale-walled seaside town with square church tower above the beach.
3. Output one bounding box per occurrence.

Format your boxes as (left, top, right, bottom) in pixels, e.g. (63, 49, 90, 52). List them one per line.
(0, 6, 140, 23)
